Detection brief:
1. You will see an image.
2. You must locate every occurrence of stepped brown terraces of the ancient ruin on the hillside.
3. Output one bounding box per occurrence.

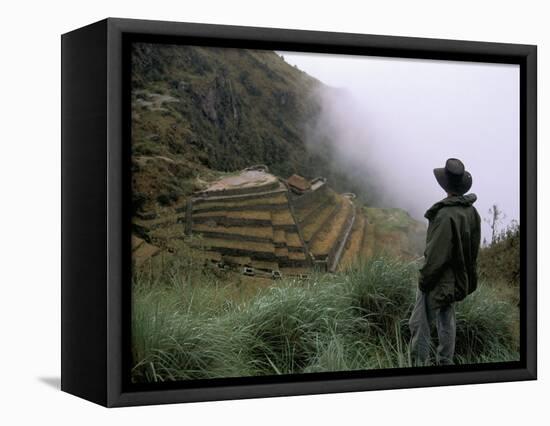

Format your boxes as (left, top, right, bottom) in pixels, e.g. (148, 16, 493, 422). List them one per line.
(185, 166, 366, 278)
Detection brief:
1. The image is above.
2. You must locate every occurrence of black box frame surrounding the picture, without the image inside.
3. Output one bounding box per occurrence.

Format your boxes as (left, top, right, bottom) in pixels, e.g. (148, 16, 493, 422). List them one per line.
(61, 18, 537, 407)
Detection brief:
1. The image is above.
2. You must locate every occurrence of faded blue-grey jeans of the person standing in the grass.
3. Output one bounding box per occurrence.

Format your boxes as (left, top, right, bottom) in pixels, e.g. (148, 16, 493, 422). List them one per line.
(409, 289, 456, 366)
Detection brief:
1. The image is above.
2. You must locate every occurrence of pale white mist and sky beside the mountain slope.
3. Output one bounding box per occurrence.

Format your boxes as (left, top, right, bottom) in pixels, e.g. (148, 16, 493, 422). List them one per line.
(279, 52, 520, 240)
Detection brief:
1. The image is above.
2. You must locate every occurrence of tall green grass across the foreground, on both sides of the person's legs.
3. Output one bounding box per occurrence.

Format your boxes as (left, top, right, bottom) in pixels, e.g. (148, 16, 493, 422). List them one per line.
(132, 259, 518, 382)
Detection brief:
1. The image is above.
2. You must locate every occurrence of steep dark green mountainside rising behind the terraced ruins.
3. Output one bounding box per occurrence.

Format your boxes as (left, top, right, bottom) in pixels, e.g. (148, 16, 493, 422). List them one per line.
(132, 43, 423, 260)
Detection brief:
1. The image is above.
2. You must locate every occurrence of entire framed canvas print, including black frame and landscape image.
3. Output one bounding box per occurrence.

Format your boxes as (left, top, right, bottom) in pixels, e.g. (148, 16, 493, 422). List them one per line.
(62, 19, 536, 406)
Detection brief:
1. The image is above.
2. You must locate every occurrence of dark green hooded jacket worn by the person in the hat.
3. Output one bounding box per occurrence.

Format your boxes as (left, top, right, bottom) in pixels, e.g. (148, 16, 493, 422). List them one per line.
(418, 194, 481, 308)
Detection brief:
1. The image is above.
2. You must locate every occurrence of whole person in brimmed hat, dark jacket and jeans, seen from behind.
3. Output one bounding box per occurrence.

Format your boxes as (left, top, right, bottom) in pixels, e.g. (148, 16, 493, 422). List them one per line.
(409, 158, 481, 366)
